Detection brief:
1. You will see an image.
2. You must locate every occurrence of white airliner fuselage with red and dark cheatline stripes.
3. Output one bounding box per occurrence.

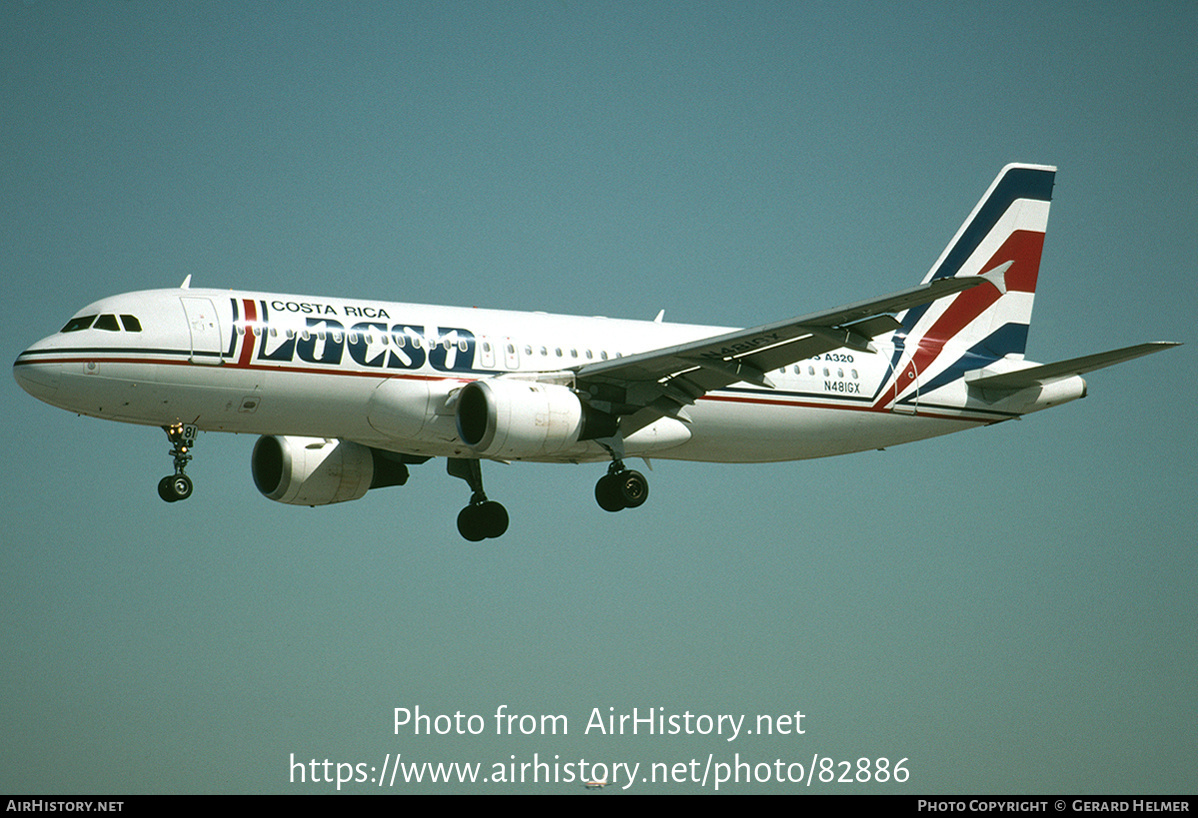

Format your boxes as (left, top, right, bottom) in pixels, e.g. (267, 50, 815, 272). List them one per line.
(9, 289, 1059, 462)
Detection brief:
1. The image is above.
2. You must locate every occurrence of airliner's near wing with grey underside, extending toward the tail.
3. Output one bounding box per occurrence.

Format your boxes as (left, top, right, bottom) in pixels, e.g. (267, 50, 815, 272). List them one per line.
(574, 270, 1012, 436)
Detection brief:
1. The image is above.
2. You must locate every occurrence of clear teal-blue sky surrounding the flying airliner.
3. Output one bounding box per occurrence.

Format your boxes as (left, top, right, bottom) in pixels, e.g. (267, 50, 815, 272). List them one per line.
(0, 0, 1198, 794)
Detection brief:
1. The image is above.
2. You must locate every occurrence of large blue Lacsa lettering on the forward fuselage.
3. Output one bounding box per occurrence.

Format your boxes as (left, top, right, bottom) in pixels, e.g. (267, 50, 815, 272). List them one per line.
(258, 317, 477, 372)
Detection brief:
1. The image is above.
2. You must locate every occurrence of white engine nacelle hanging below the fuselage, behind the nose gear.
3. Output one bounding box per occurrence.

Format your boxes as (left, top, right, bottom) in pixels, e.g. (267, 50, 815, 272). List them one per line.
(250, 436, 407, 505)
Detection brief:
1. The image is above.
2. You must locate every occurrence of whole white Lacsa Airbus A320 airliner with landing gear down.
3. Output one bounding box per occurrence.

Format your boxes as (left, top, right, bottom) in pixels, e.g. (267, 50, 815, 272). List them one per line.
(13, 164, 1174, 541)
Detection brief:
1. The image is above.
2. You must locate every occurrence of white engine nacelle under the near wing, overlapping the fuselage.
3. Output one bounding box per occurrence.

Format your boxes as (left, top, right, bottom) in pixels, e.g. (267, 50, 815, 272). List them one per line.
(456, 378, 616, 460)
